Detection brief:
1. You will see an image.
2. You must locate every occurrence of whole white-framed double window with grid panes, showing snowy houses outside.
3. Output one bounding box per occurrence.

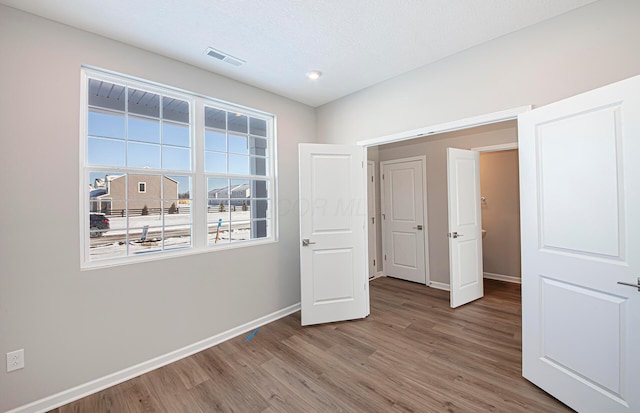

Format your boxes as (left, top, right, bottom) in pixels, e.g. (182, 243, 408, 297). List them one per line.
(81, 68, 275, 267)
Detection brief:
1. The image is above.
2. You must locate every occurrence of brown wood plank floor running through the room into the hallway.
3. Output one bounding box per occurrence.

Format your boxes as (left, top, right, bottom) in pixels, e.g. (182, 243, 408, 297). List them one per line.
(47, 278, 572, 413)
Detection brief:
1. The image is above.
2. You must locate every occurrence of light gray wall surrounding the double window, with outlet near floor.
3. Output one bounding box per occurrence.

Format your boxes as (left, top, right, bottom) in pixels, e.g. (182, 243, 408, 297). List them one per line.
(0, 6, 315, 411)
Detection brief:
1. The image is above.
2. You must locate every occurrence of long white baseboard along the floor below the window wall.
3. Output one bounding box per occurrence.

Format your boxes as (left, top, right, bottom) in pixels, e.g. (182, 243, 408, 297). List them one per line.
(6, 303, 300, 413)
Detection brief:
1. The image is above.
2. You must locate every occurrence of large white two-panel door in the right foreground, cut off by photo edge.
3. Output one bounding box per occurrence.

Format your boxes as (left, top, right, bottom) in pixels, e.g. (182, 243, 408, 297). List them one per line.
(518, 77, 640, 413)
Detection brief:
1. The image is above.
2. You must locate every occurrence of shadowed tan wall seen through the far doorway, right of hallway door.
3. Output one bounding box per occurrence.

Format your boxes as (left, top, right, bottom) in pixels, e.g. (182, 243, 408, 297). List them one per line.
(480, 149, 521, 278)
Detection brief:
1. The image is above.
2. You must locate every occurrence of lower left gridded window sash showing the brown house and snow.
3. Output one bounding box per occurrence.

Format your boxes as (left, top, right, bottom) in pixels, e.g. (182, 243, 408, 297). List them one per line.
(89, 171, 193, 260)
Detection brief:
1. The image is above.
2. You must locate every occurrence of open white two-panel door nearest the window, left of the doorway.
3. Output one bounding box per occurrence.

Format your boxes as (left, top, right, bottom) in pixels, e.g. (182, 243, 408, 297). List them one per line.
(299, 144, 369, 325)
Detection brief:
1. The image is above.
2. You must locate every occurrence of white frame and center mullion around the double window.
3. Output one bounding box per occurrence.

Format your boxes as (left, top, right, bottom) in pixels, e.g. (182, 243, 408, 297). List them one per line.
(79, 66, 279, 270)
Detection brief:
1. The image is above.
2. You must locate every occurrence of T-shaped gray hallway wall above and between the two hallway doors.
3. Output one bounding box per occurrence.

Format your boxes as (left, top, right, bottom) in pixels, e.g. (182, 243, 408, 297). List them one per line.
(378, 121, 517, 284)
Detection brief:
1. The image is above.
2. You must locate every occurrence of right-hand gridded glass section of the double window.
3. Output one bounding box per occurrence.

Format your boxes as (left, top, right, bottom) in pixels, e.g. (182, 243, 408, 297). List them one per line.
(204, 106, 271, 244)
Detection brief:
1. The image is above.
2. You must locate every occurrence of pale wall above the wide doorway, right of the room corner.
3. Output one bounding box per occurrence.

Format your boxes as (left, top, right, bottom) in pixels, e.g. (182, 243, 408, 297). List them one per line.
(317, 0, 640, 145)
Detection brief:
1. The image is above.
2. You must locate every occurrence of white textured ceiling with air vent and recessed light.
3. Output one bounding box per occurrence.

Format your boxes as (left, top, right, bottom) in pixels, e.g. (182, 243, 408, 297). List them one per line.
(0, 0, 594, 106)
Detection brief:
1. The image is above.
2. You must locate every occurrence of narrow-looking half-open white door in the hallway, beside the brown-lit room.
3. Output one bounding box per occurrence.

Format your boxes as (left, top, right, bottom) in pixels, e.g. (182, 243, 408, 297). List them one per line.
(447, 148, 484, 308)
